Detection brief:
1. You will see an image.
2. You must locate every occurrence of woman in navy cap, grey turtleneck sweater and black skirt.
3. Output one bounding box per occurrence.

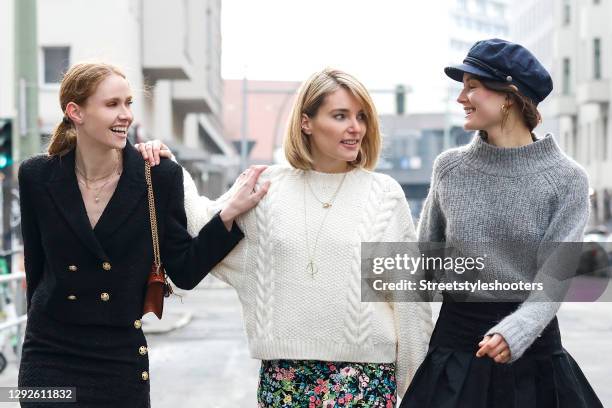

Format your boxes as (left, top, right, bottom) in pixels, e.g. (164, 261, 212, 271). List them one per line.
(401, 39, 602, 408)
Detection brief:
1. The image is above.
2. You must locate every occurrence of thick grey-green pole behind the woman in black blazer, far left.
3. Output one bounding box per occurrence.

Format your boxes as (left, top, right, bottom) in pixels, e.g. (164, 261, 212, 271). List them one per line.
(13, 0, 41, 162)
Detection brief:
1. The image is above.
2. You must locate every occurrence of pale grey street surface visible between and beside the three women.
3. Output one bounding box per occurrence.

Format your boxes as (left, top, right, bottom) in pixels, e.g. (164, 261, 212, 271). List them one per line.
(0, 285, 612, 408)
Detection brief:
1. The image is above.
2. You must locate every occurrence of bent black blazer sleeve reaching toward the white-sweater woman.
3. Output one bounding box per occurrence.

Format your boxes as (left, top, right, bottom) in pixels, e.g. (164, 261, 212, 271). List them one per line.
(158, 167, 244, 289)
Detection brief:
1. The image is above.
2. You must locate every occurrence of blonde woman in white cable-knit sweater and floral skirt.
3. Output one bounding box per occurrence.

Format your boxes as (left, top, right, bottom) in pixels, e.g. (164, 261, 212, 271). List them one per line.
(141, 69, 432, 407)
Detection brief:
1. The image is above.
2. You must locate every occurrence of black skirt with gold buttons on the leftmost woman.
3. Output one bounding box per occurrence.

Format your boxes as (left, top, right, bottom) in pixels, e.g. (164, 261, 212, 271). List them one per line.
(19, 310, 150, 408)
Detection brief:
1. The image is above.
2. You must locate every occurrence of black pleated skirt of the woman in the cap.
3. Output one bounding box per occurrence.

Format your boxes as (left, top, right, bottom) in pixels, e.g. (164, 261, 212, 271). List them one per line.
(400, 299, 603, 408)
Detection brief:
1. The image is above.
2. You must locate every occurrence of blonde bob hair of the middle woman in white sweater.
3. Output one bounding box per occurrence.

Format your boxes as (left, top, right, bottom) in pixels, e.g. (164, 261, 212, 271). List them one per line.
(283, 68, 382, 170)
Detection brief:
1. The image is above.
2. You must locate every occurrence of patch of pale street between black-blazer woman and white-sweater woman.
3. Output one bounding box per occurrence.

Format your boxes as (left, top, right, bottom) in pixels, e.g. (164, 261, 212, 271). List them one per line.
(147, 284, 259, 408)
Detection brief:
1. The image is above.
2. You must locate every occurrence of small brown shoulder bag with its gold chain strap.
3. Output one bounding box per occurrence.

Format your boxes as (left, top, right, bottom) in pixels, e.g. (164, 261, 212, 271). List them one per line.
(142, 161, 172, 319)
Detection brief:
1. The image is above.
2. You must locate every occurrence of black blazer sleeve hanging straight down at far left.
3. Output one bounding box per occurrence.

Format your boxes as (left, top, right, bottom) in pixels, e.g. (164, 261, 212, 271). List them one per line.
(18, 165, 45, 310)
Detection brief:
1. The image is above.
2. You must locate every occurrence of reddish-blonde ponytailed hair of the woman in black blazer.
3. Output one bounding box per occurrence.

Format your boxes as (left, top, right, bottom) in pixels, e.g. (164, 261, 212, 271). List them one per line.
(47, 62, 125, 156)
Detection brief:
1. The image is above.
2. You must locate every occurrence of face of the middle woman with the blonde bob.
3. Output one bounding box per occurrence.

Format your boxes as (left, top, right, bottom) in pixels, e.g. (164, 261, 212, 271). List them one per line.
(302, 87, 367, 172)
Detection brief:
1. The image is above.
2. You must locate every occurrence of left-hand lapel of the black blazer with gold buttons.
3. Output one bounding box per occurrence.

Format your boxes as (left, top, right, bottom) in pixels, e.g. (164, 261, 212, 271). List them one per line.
(47, 149, 108, 259)
